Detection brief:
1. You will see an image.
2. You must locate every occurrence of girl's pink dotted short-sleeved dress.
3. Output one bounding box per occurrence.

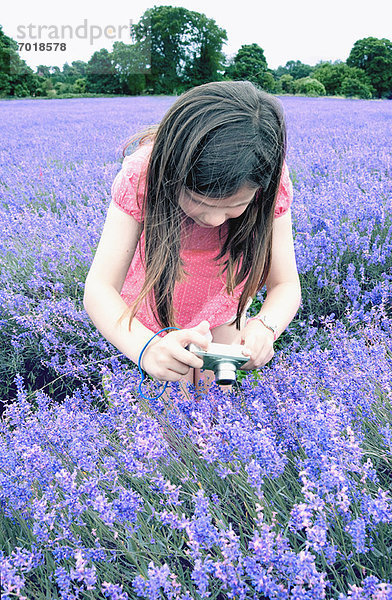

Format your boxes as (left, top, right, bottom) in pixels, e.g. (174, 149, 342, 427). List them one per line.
(111, 143, 293, 335)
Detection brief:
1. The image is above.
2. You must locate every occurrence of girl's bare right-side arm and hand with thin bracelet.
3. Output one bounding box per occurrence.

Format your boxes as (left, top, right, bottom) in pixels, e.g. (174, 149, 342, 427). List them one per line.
(241, 209, 301, 369)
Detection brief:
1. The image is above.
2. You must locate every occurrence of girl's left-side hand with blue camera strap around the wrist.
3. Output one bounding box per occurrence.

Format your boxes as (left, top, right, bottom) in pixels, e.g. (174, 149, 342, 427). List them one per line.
(142, 321, 210, 381)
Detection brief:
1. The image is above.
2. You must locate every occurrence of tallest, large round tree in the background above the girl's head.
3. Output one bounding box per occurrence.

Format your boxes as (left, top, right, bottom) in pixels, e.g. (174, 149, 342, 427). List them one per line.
(133, 6, 227, 94)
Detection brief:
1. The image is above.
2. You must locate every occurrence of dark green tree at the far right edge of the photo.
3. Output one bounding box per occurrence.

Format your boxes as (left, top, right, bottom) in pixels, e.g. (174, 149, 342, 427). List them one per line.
(347, 37, 392, 98)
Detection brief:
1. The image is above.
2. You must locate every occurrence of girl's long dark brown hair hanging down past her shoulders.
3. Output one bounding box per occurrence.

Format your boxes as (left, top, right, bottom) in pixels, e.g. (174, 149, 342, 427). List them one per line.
(119, 81, 287, 329)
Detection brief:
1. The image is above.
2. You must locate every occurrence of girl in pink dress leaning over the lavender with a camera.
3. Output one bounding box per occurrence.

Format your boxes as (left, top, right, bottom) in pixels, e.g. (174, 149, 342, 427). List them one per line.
(84, 81, 301, 398)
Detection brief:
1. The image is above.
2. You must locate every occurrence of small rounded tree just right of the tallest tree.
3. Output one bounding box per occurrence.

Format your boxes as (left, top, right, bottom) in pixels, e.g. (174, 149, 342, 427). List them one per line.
(227, 44, 268, 87)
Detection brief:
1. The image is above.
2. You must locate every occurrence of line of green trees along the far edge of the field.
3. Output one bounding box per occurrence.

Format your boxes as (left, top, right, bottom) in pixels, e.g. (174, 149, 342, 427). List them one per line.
(0, 6, 392, 99)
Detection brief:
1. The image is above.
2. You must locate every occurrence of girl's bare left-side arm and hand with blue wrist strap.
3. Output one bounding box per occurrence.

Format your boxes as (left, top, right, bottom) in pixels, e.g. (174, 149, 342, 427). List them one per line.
(83, 202, 208, 381)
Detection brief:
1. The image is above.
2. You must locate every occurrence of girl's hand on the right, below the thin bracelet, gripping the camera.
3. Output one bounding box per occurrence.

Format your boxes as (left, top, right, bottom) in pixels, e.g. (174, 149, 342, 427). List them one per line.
(237, 319, 275, 371)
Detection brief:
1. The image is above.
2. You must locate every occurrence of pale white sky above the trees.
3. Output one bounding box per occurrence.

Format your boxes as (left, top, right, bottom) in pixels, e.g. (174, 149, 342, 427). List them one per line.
(0, 0, 392, 69)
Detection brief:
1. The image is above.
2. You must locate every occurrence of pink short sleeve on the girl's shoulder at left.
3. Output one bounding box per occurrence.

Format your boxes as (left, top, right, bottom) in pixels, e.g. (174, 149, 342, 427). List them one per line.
(111, 146, 149, 223)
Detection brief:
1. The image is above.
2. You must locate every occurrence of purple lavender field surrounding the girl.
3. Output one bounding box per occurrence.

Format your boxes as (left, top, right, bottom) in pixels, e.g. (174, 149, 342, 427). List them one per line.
(0, 97, 392, 600)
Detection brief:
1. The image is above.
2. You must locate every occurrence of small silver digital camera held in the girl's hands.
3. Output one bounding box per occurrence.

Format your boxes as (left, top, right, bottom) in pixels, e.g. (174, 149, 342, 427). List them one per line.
(186, 342, 250, 385)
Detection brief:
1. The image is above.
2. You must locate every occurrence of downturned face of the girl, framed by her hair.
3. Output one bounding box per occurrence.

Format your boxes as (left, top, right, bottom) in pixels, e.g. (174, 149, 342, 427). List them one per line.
(178, 186, 257, 227)
